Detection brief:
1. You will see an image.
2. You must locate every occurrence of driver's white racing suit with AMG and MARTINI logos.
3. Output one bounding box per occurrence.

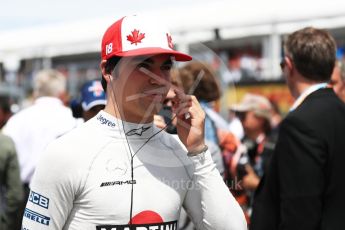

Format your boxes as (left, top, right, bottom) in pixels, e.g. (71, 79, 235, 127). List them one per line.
(22, 111, 246, 230)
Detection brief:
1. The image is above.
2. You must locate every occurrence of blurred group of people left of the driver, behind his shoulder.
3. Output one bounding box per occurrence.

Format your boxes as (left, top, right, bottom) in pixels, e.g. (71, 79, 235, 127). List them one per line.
(0, 69, 106, 230)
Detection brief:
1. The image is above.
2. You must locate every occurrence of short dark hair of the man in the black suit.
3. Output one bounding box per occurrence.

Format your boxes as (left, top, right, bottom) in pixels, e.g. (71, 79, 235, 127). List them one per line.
(285, 27, 336, 82)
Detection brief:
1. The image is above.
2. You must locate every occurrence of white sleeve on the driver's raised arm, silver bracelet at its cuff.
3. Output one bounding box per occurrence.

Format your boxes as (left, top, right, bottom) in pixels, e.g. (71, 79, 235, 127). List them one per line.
(184, 151, 247, 230)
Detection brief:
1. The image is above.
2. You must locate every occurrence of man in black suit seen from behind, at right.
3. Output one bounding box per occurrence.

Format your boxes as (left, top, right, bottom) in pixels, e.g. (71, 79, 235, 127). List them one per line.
(250, 27, 345, 230)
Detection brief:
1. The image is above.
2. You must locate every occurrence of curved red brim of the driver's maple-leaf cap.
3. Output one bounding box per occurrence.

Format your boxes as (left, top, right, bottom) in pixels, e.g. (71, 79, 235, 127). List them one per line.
(108, 47, 193, 61)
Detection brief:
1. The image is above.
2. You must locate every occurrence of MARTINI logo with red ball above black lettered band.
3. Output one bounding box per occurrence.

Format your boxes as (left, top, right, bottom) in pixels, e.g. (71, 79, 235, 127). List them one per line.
(96, 211, 177, 230)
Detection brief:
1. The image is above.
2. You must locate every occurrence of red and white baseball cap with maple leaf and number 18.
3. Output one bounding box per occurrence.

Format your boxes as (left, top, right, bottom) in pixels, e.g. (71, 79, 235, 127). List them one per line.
(102, 15, 192, 61)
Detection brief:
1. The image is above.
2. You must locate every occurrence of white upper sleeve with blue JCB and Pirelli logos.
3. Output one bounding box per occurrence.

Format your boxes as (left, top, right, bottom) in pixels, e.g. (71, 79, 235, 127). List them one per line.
(22, 145, 76, 230)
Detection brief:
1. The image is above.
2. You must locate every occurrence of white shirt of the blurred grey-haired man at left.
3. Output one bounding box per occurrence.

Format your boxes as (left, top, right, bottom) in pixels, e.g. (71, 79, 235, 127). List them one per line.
(3, 97, 76, 183)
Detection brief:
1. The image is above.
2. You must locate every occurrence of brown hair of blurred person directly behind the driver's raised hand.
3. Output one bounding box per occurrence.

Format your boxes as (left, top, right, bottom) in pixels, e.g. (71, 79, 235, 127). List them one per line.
(180, 61, 221, 102)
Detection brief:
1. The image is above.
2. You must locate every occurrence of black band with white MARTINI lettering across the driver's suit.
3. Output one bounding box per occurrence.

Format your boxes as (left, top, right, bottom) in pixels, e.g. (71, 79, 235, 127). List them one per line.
(96, 221, 177, 230)
